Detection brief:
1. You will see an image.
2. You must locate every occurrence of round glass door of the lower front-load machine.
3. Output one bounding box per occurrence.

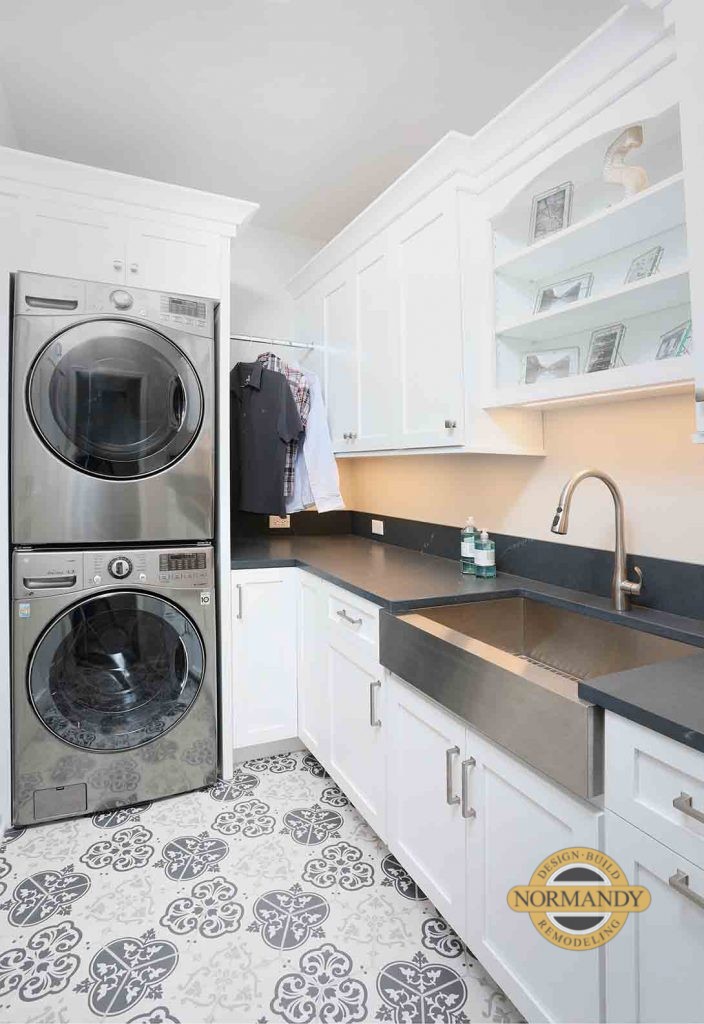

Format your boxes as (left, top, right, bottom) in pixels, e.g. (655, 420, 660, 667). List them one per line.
(29, 591, 205, 751)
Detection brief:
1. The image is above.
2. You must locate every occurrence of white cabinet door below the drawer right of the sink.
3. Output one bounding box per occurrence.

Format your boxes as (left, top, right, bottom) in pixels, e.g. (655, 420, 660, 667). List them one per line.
(605, 811, 704, 1024)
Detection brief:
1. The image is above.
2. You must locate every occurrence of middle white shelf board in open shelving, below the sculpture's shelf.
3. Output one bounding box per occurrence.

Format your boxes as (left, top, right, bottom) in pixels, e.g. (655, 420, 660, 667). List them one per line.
(496, 267, 690, 344)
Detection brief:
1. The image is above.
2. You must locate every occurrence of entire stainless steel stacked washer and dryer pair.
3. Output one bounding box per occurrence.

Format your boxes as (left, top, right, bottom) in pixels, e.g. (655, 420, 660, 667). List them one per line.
(10, 272, 217, 825)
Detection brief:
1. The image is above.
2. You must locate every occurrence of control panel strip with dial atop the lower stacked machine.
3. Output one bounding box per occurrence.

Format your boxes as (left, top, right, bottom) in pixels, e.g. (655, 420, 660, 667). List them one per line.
(12, 545, 215, 598)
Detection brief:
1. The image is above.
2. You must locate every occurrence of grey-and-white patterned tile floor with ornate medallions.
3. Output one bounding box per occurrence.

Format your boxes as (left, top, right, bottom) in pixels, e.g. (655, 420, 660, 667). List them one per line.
(0, 753, 522, 1024)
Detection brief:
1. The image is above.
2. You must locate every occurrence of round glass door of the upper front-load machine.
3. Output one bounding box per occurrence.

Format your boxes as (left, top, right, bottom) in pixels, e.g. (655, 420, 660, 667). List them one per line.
(28, 319, 203, 479)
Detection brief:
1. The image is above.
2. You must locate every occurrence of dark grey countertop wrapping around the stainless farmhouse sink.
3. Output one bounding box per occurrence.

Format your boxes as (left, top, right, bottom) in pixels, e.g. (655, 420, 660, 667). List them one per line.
(231, 535, 704, 751)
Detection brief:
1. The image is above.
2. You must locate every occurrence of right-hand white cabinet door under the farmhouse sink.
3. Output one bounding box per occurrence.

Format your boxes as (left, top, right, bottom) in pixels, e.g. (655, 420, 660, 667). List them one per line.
(465, 730, 604, 1024)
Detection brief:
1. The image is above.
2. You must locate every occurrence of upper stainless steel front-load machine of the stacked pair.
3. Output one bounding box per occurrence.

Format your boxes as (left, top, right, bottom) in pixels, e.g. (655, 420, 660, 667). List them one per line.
(11, 272, 215, 545)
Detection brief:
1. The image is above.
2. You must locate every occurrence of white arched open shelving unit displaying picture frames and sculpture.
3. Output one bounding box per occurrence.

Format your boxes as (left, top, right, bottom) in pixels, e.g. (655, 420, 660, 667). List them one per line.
(483, 108, 694, 409)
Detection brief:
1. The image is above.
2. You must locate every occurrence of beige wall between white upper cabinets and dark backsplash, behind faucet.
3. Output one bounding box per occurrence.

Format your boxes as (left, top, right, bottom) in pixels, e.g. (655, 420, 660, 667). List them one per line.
(340, 395, 704, 563)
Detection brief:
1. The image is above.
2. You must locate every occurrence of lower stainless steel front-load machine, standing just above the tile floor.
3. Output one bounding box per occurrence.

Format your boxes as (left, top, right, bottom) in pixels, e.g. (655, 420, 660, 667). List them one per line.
(12, 546, 217, 825)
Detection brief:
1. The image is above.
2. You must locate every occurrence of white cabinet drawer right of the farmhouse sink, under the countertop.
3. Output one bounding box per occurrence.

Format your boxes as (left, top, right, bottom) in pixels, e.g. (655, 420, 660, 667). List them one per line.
(604, 714, 704, 867)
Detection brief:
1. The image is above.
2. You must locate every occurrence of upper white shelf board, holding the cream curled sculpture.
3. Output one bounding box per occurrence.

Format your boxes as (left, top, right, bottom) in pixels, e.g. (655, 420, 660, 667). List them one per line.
(494, 173, 685, 283)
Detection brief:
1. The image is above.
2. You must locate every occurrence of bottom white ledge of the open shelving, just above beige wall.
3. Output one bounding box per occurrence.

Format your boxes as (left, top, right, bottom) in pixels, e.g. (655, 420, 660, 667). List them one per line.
(483, 355, 694, 409)
